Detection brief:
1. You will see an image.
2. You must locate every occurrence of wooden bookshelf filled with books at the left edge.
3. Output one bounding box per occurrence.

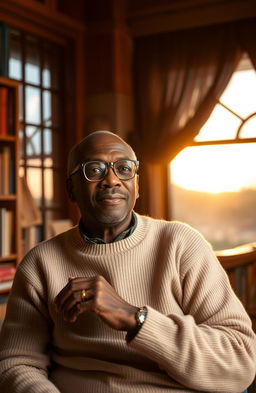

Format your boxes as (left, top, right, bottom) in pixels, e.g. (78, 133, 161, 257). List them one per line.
(0, 77, 20, 294)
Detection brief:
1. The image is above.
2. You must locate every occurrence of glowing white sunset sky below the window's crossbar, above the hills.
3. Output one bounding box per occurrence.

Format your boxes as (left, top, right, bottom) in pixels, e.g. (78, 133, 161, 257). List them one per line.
(171, 143, 256, 194)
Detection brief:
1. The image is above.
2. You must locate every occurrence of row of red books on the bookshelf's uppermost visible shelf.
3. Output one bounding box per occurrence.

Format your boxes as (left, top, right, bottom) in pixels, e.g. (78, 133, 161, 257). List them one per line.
(0, 86, 13, 135)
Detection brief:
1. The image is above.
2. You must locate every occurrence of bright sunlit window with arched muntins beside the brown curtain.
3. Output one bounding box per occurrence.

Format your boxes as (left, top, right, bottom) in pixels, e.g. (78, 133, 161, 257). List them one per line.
(170, 55, 256, 250)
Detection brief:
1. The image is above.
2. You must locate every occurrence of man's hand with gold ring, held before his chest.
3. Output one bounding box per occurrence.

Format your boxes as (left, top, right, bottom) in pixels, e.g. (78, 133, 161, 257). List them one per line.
(55, 276, 138, 332)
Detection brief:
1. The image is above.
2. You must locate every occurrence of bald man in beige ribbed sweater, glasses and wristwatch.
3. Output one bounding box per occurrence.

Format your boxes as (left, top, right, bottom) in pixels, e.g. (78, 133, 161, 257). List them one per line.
(0, 131, 256, 393)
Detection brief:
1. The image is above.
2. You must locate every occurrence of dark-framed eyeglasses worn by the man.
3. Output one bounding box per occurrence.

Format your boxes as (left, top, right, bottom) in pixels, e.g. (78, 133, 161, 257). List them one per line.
(70, 160, 139, 181)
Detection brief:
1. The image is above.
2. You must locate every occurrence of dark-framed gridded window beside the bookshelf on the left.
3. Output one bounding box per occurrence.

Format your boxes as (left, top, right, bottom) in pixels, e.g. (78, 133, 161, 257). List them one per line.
(9, 29, 64, 241)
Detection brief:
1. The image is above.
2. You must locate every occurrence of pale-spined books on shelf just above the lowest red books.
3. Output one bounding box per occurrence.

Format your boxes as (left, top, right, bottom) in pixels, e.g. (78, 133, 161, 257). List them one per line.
(0, 207, 14, 257)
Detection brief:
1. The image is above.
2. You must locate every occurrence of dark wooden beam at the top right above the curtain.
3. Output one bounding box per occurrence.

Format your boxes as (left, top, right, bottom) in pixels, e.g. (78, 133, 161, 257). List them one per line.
(127, 0, 256, 36)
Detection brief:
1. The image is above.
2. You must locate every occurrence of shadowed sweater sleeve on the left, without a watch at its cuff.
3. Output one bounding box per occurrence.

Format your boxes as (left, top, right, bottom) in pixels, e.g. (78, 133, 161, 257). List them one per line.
(0, 269, 60, 393)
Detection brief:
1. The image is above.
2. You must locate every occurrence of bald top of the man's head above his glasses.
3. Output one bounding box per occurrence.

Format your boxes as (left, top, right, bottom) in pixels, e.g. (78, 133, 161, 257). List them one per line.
(67, 131, 136, 176)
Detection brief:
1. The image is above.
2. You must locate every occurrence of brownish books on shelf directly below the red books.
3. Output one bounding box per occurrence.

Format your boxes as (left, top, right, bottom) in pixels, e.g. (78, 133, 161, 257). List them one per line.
(0, 145, 15, 195)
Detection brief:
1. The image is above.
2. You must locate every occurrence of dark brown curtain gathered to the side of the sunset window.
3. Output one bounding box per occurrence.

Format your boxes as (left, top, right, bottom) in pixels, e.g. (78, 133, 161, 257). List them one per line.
(130, 24, 241, 218)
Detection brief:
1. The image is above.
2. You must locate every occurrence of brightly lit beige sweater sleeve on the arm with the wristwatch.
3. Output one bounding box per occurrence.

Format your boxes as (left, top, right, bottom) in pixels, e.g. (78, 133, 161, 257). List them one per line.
(128, 227, 256, 393)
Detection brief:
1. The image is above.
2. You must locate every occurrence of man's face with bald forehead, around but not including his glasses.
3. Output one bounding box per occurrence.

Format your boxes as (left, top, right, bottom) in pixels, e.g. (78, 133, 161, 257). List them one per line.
(68, 134, 138, 229)
